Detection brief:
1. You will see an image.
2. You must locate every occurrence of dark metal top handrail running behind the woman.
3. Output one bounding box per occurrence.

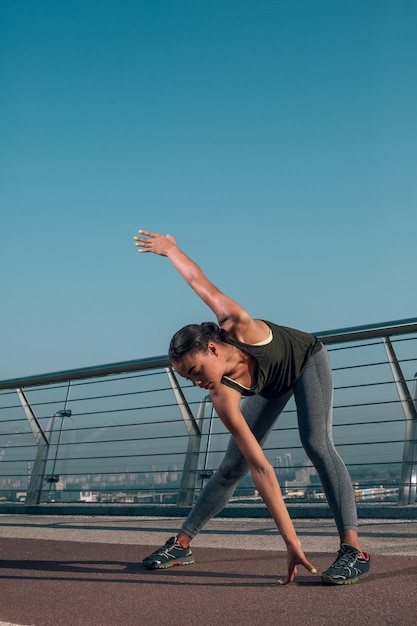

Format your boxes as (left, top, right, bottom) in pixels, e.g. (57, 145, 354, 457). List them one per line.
(0, 317, 417, 390)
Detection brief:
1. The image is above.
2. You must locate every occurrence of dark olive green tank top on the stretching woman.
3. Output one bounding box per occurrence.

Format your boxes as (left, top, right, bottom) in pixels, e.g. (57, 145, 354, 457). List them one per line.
(222, 320, 322, 398)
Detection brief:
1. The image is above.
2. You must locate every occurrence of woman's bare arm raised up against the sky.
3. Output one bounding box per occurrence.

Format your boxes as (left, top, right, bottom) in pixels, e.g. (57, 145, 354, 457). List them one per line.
(134, 230, 254, 334)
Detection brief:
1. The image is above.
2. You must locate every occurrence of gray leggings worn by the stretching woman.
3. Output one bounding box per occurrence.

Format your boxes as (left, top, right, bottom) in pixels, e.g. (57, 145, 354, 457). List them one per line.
(182, 346, 358, 537)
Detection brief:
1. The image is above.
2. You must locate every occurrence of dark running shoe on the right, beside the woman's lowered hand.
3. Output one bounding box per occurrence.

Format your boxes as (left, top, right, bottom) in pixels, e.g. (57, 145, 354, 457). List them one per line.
(321, 543, 370, 585)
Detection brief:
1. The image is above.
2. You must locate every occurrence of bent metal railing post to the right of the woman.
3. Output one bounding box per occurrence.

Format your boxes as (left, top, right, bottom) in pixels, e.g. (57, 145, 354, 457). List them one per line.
(383, 337, 417, 506)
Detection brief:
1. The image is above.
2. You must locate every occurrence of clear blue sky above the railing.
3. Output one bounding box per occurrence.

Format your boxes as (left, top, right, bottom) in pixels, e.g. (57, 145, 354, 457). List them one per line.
(0, 0, 417, 379)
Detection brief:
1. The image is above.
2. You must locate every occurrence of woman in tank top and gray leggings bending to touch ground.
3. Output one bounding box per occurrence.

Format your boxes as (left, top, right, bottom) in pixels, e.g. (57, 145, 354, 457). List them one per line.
(135, 230, 369, 584)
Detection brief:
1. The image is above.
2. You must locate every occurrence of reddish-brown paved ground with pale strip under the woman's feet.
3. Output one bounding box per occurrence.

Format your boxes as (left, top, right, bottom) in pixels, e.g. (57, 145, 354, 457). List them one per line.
(0, 515, 417, 626)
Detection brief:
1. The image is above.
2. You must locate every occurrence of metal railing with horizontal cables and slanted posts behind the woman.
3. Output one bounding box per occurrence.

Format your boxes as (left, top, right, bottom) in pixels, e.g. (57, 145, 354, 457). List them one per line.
(0, 318, 417, 506)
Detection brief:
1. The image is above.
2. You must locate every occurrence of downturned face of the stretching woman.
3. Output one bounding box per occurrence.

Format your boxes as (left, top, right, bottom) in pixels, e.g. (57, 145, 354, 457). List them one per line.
(173, 343, 224, 390)
